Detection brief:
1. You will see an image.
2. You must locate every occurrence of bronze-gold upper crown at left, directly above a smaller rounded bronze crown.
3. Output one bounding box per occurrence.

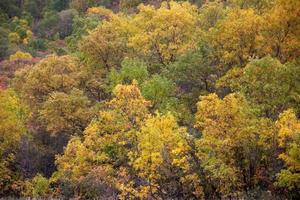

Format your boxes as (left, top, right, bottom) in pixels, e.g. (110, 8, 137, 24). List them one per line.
(13, 55, 81, 108)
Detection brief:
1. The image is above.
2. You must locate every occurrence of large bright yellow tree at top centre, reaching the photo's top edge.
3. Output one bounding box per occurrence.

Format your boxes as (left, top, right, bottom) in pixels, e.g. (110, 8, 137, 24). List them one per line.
(128, 1, 200, 65)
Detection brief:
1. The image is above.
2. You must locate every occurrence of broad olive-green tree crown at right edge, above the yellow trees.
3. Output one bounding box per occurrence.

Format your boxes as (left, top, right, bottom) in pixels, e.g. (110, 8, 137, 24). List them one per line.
(218, 56, 300, 118)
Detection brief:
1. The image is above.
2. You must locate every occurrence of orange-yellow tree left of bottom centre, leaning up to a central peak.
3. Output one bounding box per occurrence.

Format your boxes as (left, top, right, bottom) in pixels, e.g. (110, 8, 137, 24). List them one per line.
(53, 84, 149, 198)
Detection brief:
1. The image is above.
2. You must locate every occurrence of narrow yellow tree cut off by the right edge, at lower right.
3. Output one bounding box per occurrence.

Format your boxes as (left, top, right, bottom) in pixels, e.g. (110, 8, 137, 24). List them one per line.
(276, 110, 300, 191)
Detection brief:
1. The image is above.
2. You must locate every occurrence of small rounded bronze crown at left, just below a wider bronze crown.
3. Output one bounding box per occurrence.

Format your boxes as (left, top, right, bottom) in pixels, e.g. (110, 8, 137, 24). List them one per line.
(39, 89, 93, 135)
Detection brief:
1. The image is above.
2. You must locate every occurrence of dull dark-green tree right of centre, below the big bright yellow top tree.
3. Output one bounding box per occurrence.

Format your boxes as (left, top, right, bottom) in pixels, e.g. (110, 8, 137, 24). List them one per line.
(167, 44, 219, 111)
